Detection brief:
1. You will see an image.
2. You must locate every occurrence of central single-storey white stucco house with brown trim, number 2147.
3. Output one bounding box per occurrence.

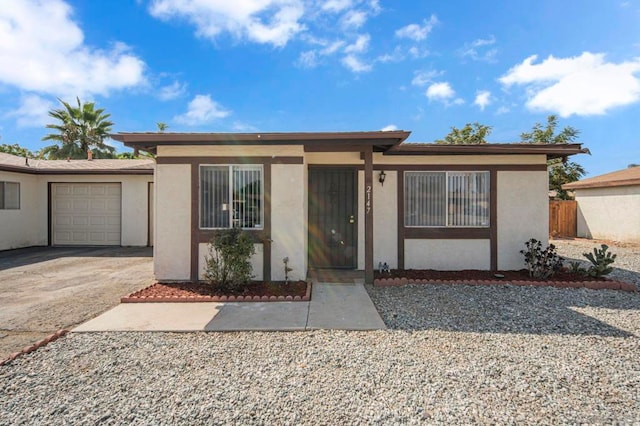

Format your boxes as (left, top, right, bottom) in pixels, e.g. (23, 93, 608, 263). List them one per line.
(112, 131, 581, 282)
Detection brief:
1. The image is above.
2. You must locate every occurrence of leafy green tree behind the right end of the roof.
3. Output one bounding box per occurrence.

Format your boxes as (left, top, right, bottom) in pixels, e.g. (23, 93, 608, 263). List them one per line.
(520, 115, 586, 200)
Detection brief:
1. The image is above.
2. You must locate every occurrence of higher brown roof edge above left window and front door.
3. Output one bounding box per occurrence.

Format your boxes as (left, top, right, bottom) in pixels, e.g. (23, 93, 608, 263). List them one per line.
(110, 130, 411, 153)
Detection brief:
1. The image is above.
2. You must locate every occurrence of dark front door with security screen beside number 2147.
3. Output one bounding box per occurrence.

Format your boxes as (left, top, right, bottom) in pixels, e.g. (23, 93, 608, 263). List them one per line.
(309, 167, 358, 269)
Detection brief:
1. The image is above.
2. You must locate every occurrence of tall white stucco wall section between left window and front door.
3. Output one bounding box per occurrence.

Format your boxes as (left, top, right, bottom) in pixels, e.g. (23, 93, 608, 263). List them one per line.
(271, 164, 307, 281)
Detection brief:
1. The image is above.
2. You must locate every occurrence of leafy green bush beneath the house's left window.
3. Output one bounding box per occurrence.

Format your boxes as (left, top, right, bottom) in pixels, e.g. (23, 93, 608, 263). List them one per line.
(204, 228, 255, 293)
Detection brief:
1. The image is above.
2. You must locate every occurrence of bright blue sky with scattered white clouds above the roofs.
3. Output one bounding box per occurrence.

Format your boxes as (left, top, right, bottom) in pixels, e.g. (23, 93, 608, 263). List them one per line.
(0, 0, 640, 175)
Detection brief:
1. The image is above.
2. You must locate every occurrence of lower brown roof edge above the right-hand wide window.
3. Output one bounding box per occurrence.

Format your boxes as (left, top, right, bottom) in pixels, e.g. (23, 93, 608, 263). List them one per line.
(383, 143, 589, 159)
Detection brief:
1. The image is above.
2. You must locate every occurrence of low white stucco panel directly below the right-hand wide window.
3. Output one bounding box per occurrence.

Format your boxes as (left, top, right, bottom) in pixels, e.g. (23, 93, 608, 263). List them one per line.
(404, 240, 491, 271)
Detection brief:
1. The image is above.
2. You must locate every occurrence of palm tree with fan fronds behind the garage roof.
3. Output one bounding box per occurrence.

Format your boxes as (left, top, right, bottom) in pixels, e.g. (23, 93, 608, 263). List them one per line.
(42, 98, 115, 159)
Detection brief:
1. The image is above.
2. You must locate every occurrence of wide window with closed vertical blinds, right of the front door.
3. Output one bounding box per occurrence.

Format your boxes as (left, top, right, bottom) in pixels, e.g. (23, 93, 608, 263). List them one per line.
(404, 172, 489, 228)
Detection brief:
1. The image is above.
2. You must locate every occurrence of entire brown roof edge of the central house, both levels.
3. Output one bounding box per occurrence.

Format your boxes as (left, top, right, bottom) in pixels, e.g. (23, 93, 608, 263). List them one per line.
(111, 130, 589, 158)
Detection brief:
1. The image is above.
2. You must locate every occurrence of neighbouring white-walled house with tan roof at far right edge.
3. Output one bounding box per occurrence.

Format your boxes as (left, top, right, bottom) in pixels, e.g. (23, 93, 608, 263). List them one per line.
(562, 167, 640, 242)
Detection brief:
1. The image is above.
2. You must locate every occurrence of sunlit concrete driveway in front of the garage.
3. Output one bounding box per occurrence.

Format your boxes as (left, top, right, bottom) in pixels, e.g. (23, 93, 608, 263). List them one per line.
(0, 247, 153, 359)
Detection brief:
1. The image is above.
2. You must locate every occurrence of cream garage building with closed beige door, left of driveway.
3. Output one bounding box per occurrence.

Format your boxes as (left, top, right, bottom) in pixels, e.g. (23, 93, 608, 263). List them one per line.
(0, 153, 155, 250)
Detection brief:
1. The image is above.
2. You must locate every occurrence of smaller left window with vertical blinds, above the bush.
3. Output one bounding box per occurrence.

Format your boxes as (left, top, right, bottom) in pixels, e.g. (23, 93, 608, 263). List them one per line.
(200, 166, 263, 229)
